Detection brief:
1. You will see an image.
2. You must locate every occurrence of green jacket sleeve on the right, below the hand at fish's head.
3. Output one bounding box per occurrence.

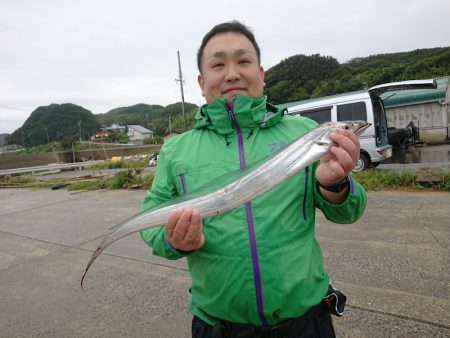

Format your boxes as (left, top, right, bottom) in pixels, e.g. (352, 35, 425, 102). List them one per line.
(314, 163, 367, 224)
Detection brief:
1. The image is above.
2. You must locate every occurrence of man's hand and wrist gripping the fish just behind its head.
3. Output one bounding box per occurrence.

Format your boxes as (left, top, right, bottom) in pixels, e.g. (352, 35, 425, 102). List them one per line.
(316, 130, 360, 203)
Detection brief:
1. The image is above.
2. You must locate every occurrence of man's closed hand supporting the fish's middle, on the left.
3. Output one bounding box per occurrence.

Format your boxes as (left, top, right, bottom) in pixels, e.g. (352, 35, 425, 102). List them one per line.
(166, 209, 205, 251)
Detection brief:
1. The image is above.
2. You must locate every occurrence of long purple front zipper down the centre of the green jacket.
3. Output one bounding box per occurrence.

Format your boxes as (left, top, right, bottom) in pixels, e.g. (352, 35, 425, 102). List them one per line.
(227, 97, 268, 325)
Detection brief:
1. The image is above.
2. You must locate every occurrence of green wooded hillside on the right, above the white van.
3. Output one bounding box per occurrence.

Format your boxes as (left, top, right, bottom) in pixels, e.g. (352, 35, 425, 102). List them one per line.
(265, 47, 450, 104)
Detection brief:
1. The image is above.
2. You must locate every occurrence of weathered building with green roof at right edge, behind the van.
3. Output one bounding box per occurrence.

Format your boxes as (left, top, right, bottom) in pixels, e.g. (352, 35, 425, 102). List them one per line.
(381, 76, 450, 143)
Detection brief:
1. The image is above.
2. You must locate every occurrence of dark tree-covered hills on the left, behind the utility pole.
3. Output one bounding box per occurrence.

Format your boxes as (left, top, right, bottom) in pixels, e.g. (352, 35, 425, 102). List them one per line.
(4, 102, 197, 148)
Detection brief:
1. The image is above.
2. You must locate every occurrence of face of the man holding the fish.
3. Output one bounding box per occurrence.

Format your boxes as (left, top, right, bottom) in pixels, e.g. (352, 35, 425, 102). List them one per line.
(198, 32, 264, 103)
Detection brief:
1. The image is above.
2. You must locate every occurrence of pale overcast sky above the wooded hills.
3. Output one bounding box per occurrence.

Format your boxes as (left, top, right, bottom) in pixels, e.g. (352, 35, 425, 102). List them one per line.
(0, 0, 450, 133)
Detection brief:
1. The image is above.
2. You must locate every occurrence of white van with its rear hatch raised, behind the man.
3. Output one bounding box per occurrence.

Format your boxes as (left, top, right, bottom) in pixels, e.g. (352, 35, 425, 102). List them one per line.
(280, 80, 436, 171)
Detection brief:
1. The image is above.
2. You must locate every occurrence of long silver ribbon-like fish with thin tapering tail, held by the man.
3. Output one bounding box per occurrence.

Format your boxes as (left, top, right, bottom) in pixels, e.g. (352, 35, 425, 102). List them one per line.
(81, 121, 370, 286)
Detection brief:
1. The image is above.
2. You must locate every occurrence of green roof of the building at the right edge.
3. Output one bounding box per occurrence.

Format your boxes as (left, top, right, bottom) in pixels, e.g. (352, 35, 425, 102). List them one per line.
(381, 76, 450, 108)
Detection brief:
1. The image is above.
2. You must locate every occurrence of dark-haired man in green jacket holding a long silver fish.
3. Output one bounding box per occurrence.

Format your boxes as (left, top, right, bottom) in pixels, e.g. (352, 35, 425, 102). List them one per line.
(141, 21, 366, 337)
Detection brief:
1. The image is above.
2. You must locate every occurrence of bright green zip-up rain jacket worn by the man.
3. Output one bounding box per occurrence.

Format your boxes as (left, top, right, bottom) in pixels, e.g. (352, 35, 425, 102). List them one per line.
(141, 96, 366, 325)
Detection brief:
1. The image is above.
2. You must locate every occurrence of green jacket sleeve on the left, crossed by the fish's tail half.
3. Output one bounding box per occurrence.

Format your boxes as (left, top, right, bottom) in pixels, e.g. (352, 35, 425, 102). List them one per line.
(140, 147, 191, 259)
